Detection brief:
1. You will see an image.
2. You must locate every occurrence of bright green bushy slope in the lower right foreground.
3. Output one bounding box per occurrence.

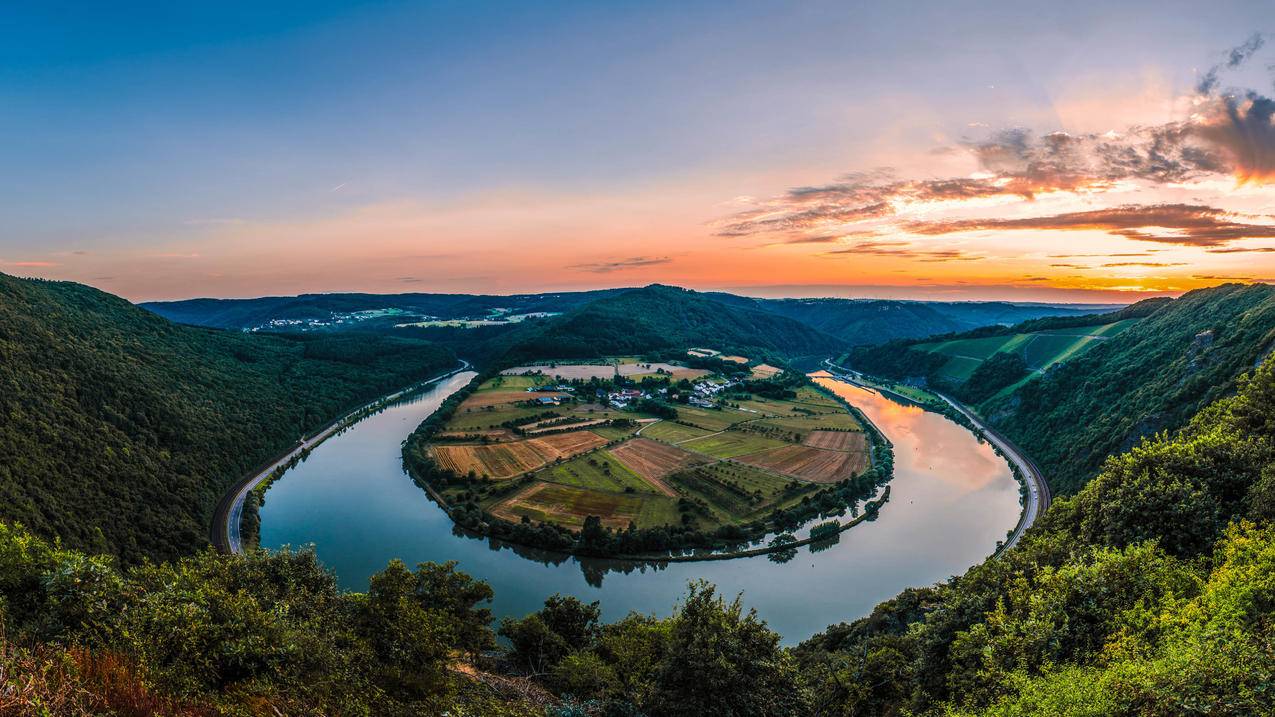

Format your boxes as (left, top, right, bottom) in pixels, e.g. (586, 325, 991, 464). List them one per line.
(798, 349, 1275, 717)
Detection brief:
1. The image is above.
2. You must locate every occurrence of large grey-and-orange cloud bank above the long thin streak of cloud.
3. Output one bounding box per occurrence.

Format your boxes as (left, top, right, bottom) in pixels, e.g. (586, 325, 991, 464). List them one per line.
(718, 34, 1275, 246)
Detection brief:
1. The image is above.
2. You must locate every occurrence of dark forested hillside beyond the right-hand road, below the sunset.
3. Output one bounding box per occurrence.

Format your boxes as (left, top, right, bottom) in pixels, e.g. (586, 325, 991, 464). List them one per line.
(847, 285, 1275, 492)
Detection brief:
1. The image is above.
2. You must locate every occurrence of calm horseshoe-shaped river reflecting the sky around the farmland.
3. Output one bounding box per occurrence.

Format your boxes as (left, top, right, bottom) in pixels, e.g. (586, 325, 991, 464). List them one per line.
(253, 371, 1020, 635)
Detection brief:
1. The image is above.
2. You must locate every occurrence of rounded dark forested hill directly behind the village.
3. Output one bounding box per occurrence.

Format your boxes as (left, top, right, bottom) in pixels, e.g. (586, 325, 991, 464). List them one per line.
(501, 285, 844, 361)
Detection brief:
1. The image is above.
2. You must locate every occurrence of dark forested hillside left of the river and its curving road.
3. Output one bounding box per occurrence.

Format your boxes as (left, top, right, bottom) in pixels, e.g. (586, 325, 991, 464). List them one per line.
(0, 274, 455, 563)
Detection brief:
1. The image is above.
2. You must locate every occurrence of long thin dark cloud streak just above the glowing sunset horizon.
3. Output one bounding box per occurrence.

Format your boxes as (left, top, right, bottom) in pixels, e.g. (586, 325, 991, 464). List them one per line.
(903, 204, 1275, 246)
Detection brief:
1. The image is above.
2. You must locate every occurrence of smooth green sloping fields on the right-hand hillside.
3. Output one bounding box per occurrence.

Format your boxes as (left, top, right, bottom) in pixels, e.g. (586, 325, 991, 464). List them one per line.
(914, 319, 1137, 387)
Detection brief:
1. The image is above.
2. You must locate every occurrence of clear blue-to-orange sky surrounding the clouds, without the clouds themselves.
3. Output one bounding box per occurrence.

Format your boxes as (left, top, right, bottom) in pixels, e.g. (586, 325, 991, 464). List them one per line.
(0, 1, 1270, 299)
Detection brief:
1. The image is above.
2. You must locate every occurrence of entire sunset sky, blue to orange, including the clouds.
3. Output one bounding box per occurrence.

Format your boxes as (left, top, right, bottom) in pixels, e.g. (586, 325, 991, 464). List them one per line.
(0, 0, 1275, 302)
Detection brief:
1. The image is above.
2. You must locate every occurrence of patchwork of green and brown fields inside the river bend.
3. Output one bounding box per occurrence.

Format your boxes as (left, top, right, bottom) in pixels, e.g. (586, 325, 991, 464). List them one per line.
(430, 357, 867, 529)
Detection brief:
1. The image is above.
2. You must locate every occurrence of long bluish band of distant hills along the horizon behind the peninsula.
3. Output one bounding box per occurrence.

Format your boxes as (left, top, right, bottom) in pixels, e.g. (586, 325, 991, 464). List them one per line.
(142, 285, 1114, 357)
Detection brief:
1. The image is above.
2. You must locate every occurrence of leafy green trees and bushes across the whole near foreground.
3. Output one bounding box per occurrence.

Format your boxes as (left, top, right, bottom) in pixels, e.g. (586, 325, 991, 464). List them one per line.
(0, 331, 1275, 717)
